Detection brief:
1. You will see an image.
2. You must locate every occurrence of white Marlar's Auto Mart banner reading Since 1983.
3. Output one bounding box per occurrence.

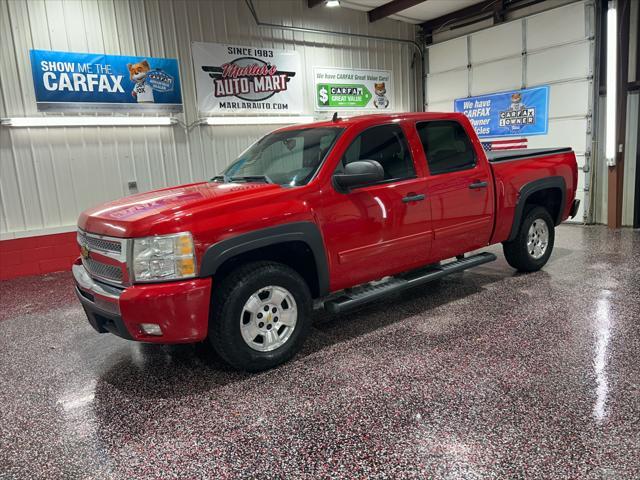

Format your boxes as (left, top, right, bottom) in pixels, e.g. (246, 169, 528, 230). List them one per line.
(191, 42, 303, 115)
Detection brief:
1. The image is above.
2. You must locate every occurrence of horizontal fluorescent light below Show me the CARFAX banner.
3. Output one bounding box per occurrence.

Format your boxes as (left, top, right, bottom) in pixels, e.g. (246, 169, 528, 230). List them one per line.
(2, 115, 177, 127)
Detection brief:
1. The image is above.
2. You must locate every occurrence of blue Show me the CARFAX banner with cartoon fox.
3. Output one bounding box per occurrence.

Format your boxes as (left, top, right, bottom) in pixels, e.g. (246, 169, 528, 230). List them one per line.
(31, 50, 182, 111)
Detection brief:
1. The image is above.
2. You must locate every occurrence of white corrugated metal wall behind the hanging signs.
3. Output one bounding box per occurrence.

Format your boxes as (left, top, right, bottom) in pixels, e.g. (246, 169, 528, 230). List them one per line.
(0, 0, 420, 239)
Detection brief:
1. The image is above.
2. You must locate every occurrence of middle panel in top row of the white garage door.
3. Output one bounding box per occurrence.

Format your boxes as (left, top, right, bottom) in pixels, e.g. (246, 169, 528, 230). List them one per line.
(470, 22, 522, 63)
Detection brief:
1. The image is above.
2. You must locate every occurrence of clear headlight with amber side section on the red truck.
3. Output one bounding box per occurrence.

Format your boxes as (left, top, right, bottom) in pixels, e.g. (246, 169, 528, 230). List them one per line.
(131, 232, 196, 282)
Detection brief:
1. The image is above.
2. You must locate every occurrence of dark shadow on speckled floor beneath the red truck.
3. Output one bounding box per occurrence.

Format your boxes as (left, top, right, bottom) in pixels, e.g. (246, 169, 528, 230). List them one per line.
(96, 266, 513, 401)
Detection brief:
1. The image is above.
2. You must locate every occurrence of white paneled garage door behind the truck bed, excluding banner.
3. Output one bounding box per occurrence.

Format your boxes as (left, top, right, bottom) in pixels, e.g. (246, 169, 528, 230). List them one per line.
(425, 2, 594, 221)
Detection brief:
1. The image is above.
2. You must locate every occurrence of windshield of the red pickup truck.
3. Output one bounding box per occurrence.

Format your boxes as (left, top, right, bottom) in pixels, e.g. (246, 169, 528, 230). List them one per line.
(218, 127, 342, 187)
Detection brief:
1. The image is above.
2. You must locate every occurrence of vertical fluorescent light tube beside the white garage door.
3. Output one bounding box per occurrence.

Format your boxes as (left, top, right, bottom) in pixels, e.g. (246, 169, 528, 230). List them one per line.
(605, 1, 618, 167)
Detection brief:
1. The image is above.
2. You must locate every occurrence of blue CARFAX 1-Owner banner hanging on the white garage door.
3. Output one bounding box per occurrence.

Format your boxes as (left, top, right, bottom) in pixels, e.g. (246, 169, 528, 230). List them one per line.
(454, 86, 549, 137)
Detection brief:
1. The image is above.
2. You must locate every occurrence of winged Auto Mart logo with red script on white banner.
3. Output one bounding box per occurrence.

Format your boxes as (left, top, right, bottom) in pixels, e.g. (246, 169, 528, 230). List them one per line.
(202, 57, 295, 101)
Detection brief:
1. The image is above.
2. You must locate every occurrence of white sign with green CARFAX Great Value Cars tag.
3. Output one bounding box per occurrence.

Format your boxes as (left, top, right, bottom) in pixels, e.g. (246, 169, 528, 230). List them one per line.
(313, 68, 394, 111)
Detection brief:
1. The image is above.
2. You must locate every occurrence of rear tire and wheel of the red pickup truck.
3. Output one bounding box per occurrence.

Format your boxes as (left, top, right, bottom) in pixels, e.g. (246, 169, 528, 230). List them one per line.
(502, 207, 555, 272)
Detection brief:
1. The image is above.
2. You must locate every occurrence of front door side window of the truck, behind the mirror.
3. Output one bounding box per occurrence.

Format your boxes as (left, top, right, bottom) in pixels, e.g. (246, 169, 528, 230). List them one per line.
(338, 125, 416, 180)
